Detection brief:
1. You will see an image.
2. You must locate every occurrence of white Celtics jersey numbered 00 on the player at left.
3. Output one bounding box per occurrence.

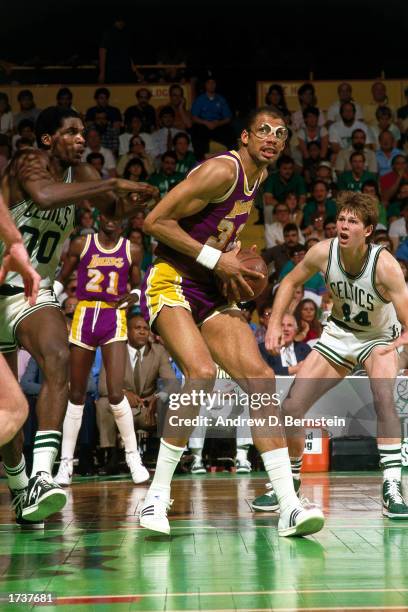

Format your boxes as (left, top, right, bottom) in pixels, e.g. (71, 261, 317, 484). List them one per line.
(0, 168, 75, 288)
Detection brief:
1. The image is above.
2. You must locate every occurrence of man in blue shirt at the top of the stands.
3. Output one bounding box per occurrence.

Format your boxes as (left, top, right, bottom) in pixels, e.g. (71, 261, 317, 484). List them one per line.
(191, 77, 234, 160)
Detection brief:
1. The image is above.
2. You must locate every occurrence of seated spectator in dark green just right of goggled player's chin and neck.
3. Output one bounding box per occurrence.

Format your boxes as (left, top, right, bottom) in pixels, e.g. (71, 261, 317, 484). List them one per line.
(263, 155, 306, 224)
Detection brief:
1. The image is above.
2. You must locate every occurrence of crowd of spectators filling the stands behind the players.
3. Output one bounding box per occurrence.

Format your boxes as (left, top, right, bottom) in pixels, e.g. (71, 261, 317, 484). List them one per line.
(0, 78, 408, 473)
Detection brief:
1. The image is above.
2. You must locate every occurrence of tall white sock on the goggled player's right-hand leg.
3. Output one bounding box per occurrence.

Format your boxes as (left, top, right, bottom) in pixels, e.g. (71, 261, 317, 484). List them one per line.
(262, 447, 299, 512)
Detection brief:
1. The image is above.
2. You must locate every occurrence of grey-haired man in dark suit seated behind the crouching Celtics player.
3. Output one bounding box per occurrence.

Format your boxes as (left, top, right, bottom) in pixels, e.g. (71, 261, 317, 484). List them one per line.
(259, 313, 312, 376)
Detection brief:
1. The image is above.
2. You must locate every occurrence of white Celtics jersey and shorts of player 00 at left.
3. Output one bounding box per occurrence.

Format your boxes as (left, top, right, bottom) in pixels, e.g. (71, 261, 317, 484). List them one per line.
(0, 168, 75, 353)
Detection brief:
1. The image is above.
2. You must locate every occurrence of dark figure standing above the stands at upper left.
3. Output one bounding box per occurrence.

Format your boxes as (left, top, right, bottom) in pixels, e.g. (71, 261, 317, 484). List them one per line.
(98, 15, 143, 83)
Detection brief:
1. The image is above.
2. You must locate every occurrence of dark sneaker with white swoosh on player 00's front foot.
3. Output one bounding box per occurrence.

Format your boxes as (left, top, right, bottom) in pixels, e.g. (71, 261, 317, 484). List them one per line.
(22, 472, 67, 521)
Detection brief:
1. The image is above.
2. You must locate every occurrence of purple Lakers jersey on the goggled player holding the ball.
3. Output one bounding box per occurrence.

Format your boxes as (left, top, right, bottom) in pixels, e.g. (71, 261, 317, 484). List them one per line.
(156, 151, 261, 282)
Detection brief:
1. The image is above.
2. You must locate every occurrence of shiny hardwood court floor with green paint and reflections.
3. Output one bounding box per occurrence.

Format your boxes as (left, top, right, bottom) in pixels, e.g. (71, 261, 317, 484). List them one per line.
(0, 472, 408, 612)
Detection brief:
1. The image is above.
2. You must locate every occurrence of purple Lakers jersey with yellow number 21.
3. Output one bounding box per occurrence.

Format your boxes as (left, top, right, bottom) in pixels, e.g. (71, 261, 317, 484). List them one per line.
(77, 234, 132, 302)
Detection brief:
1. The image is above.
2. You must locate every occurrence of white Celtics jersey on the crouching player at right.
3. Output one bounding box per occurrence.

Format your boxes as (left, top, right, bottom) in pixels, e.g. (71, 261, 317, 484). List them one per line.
(326, 238, 400, 337)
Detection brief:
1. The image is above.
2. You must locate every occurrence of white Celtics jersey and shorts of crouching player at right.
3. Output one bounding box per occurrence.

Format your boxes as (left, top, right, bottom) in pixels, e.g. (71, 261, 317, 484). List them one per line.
(313, 238, 401, 370)
